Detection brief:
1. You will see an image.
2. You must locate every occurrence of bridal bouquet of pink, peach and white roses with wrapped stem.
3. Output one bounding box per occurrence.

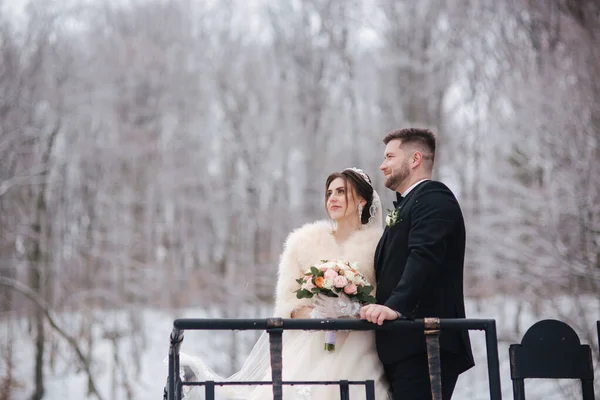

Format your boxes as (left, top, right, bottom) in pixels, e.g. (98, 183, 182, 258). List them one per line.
(295, 260, 375, 351)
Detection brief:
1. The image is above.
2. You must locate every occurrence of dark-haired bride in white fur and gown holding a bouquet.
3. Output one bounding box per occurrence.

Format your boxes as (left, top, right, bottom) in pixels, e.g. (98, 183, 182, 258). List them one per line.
(173, 168, 388, 400)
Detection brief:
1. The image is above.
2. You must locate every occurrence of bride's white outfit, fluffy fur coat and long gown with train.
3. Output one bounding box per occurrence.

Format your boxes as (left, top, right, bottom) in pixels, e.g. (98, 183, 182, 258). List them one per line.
(171, 221, 388, 400)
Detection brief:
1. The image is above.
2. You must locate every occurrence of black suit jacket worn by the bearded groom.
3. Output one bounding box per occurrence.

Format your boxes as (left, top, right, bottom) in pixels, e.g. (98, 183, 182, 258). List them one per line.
(375, 181, 474, 372)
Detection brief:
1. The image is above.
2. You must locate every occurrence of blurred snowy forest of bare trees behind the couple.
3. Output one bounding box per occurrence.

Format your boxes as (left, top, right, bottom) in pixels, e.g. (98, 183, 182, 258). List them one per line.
(0, 0, 600, 400)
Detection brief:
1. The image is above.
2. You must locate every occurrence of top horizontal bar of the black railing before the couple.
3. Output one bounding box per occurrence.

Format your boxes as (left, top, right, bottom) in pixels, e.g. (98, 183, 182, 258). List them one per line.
(173, 318, 495, 331)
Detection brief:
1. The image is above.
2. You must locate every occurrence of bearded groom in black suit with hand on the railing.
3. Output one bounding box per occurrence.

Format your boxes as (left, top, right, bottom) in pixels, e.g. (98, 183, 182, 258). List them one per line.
(361, 128, 474, 400)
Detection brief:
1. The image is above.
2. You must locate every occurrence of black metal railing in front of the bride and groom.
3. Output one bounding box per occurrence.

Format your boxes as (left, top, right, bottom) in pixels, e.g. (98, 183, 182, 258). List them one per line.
(167, 318, 502, 400)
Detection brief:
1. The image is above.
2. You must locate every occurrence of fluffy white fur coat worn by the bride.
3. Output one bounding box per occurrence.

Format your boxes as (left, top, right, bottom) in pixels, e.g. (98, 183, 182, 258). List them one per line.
(274, 221, 382, 318)
